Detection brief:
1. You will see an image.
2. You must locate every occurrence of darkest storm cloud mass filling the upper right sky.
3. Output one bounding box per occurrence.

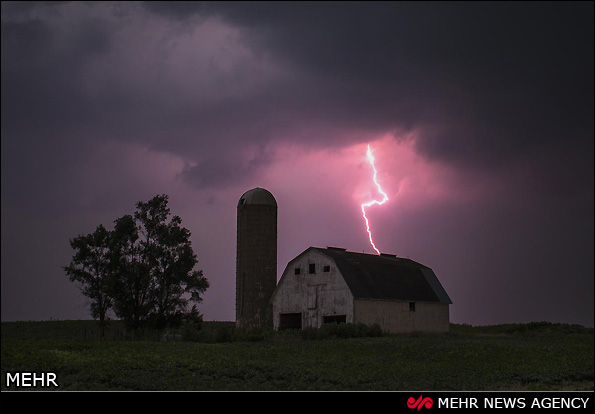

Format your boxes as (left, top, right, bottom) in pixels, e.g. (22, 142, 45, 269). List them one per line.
(141, 2, 594, 175)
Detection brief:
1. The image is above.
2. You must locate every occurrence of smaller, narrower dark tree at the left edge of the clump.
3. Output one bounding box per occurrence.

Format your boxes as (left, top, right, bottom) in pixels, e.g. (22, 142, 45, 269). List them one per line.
(64, 225, 112, 337)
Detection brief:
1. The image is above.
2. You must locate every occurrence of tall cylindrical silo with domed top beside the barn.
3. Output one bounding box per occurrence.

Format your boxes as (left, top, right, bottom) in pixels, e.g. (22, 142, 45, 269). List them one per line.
(236, 188, 277, 328)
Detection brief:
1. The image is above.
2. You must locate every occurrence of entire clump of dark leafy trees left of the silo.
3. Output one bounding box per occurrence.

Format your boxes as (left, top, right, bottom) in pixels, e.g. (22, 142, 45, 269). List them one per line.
(64, 195, 209, 335)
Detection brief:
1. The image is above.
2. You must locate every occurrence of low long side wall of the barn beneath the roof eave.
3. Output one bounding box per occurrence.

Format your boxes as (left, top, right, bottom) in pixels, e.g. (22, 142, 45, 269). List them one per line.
(354, 299, 449, 333)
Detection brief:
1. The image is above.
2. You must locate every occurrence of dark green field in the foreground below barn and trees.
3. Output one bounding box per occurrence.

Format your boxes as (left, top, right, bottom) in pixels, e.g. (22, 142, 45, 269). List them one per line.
(1, 321, 594, 391)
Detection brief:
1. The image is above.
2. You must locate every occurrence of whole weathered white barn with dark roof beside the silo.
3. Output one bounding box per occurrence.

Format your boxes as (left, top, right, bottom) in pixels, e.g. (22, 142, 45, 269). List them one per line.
(271, 247, 452, 333)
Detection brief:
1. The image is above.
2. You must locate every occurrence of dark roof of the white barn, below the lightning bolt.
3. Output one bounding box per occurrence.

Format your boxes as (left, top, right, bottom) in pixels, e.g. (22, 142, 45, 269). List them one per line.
(312, 247, 452, 304)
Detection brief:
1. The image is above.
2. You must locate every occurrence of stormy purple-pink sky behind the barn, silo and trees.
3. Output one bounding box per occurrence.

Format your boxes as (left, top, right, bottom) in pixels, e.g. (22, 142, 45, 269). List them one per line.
(1, 1, 594, 326)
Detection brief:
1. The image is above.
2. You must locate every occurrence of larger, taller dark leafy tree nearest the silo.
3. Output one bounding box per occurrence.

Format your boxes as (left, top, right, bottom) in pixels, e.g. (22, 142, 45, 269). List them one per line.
(112, 195, 209, 329)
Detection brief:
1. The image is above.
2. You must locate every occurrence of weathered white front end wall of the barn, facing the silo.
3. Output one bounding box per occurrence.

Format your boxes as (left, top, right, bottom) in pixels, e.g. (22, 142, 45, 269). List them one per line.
(272, 251, 353, 329)
